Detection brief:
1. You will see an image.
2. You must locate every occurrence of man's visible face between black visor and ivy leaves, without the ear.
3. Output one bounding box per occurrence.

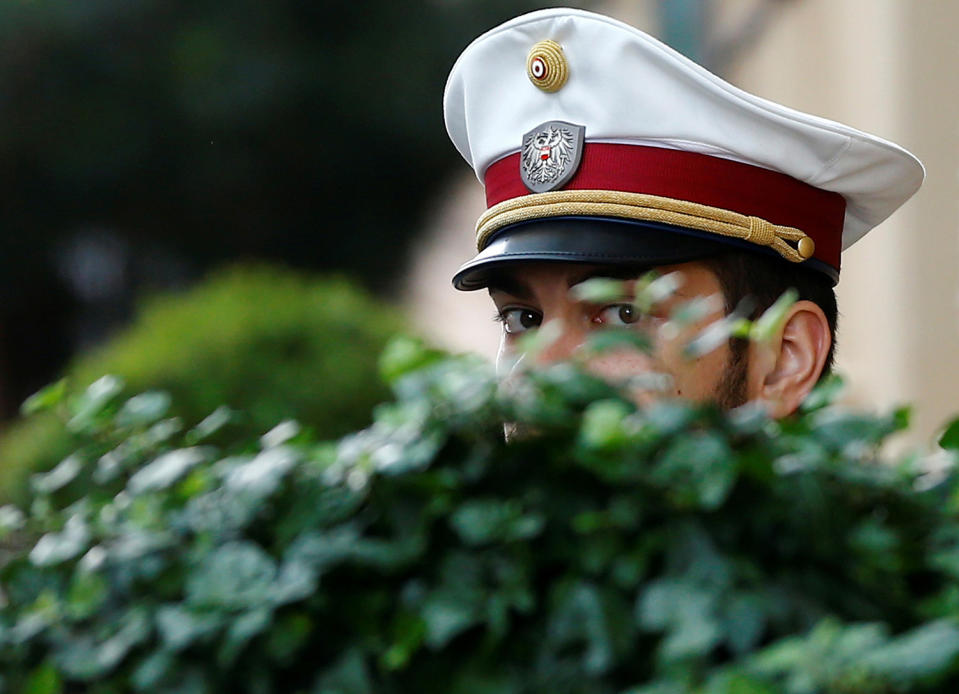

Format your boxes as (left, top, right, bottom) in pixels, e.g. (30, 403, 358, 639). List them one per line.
(490, 262, 746, 407)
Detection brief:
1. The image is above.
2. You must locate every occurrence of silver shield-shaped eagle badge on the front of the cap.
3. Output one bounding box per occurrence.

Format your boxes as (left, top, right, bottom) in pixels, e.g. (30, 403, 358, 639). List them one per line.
(519, 120, 586, 193)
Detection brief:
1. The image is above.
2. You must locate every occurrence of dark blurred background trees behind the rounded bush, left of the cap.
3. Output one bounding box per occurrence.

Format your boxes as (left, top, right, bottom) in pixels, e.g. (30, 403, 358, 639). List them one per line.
(0, 0, 568, 416)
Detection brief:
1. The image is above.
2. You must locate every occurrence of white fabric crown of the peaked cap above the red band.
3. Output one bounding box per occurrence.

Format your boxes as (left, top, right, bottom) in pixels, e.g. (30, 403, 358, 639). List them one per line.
(444, 8, 924, 288)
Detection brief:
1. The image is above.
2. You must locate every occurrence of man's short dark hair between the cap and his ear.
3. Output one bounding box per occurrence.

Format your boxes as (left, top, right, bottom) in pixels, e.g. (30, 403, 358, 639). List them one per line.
(703, 251, 838, 378)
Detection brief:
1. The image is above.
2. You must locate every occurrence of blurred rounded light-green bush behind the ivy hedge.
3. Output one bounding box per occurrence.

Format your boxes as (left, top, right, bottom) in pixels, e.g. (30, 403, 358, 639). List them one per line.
(0, 266, 402, 499)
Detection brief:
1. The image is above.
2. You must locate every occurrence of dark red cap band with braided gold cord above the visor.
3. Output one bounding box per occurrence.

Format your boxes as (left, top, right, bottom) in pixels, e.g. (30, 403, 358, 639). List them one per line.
(477, 142, 846, 271)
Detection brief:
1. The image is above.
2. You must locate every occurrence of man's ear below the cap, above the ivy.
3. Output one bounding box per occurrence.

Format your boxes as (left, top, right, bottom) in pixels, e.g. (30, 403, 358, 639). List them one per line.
(747, 301, 832, 418)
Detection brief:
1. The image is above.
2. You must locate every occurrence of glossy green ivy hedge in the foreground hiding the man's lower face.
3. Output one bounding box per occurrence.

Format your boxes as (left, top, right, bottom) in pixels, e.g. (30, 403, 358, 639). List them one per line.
(0, 340, 959, 694)
